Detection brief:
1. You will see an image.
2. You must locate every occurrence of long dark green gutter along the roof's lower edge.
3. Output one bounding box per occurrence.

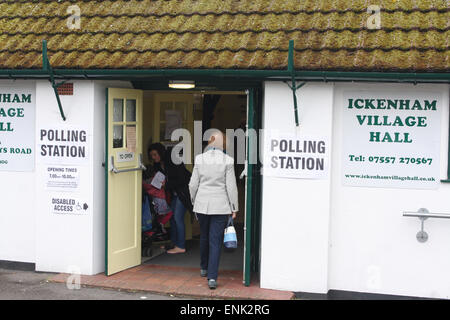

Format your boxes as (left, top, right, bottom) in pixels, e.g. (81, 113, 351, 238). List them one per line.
(0, 69, 450, 83)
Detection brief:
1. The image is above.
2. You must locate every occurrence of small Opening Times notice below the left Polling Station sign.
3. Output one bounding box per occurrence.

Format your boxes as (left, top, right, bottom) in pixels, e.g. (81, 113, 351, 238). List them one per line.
(45, 166, 80, 192)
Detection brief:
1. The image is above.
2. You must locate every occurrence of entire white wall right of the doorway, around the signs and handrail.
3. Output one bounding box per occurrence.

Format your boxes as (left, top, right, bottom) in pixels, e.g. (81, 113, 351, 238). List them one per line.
(260, 82, 450, 298)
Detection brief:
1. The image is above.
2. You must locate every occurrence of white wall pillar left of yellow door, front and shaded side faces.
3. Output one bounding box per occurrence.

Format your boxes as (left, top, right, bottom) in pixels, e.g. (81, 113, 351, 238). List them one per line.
(35, 81, 130, 275)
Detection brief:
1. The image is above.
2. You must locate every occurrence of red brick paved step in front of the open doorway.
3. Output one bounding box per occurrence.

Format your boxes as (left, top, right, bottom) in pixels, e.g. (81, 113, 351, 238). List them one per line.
(50, 264, 294, 300)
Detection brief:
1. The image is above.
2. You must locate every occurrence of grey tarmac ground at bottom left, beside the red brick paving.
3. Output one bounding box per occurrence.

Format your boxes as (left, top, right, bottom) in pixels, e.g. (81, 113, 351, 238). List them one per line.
(0, 268, 180, 300)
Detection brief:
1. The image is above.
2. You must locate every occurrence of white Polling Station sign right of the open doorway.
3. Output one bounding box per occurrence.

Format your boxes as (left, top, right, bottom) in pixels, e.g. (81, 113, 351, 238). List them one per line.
(264, 133, 330, 179)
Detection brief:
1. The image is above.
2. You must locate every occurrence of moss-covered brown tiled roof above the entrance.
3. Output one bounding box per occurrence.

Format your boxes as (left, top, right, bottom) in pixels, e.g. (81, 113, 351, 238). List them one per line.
(0, 0, 450, 72)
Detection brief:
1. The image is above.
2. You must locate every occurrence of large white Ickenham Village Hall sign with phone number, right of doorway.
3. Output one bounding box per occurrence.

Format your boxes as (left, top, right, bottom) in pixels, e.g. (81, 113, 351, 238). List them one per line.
(342, 91, 442, 189)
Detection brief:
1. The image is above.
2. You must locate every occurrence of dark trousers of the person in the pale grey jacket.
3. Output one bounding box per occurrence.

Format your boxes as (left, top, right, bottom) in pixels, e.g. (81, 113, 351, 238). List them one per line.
(197, 213, 229, 280)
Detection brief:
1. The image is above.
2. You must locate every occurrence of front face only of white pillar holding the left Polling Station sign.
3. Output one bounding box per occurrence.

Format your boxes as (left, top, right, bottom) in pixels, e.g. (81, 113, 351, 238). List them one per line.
(36, 81, 97, 274)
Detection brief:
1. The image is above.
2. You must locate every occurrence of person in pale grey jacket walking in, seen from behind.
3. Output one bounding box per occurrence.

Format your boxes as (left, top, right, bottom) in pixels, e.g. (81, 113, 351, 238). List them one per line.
(189, 130, 238, 289)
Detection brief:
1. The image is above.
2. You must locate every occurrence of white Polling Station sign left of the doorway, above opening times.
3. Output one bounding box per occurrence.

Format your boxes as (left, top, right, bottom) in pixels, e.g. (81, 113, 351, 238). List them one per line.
(38, 126, 90, 165)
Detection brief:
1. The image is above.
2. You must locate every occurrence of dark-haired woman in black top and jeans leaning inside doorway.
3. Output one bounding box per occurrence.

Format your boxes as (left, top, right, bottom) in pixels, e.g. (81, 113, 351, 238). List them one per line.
(148, 143, 192, 254)
